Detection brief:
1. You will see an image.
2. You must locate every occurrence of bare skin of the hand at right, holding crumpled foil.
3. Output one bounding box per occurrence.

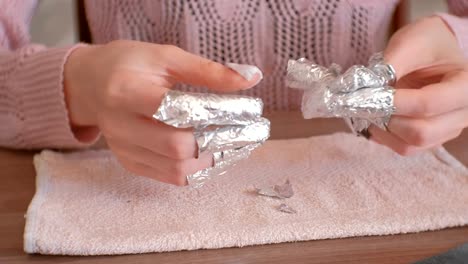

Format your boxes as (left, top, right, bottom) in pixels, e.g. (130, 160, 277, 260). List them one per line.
(369, 16, 468, 155)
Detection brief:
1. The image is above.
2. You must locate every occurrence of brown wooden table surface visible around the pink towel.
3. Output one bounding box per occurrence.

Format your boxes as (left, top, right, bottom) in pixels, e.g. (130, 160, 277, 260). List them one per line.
(0, 113, 468, 264)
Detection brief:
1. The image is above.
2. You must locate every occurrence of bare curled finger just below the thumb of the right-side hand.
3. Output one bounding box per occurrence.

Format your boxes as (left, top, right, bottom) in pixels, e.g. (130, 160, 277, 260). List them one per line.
(394, 74, 468, 118)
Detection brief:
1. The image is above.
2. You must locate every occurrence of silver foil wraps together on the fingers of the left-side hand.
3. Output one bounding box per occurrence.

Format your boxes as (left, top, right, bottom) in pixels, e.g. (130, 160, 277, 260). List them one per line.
(153, 90, 270, 187)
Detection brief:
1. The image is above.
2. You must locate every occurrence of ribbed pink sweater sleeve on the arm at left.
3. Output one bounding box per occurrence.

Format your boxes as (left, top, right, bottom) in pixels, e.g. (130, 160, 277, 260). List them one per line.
(0, 0, 98, 149)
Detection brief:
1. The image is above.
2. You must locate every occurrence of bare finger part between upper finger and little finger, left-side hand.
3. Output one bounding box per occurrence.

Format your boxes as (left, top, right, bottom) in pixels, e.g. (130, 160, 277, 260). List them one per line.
(109, 141, 213, 178)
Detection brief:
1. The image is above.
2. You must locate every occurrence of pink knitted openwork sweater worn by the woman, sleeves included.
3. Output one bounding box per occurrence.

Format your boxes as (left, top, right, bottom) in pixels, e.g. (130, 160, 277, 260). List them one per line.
(0, 0, 468, 148)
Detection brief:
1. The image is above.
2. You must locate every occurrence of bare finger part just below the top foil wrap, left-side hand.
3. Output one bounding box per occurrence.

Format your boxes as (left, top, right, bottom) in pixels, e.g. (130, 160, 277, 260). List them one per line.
(100, 112, 198, 160)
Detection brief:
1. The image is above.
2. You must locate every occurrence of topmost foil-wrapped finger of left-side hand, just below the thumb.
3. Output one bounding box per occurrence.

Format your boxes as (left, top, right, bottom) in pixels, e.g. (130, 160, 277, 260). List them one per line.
(153, 90, 263, 128)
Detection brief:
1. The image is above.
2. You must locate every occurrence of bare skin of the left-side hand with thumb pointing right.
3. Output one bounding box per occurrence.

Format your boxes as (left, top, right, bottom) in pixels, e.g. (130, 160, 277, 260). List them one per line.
(64, 40, 261, 185)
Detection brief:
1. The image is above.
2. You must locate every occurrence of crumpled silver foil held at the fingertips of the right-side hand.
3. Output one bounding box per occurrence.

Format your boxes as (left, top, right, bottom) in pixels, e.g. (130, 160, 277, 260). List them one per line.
(286, 53, 396, 135)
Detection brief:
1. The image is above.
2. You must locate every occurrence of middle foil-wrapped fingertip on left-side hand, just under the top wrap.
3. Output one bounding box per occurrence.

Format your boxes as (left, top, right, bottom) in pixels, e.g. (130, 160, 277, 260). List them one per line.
(194, 117, 270, 154)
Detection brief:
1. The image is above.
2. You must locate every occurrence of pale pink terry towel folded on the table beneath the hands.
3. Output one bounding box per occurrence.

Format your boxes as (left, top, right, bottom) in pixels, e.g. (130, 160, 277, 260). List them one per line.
(24, 133, 468, 255)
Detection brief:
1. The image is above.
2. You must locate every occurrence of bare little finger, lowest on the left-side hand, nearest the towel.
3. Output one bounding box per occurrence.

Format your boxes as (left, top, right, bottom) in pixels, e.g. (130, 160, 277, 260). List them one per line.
(112, 154, 188, 186)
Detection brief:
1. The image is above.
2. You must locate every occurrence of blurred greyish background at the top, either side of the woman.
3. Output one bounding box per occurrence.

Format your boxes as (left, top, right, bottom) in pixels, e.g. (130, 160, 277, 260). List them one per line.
(31, 0, 447, 46)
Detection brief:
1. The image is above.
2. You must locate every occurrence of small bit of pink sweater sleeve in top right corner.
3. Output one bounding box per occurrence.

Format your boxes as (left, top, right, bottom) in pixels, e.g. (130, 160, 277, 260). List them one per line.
(438, 0, 468, 58)
